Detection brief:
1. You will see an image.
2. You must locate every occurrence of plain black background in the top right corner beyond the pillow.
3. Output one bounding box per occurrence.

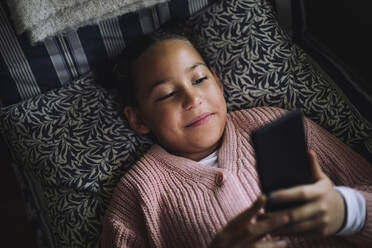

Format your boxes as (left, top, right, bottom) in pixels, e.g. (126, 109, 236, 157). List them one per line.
(302, 0, 372, 96)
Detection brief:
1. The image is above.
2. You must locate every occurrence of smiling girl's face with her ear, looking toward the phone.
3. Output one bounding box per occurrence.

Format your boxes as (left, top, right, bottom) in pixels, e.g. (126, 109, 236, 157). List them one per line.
(124, 39, 227, 160)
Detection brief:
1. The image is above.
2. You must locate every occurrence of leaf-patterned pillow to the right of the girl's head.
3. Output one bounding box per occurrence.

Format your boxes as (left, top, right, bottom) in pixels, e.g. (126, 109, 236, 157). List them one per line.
(187, 0, 372, 161)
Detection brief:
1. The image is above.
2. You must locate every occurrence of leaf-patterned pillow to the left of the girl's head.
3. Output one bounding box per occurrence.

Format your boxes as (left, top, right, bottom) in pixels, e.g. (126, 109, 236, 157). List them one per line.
(0, 74, 151, 247)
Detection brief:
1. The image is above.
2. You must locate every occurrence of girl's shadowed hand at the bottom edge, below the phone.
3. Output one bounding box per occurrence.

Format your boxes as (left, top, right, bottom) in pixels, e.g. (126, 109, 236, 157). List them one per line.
(211, 196, 289, 248)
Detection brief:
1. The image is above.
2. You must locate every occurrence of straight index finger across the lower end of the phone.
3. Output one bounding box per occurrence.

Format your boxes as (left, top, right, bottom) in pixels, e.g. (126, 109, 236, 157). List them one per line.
(270, 180, 328, 203)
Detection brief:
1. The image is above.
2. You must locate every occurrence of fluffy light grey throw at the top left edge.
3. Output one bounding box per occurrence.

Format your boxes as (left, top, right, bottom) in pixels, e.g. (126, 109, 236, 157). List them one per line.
(7, 0, 169, 43)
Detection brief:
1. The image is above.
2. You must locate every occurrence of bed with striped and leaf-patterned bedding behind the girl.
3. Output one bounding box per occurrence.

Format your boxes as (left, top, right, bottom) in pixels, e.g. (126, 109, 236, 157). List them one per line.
(0, 0, 372, 247)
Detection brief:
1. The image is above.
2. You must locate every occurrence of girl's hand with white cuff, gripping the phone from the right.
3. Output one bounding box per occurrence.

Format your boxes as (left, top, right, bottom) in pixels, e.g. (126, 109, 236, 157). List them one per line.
(265, 151, 345, 237)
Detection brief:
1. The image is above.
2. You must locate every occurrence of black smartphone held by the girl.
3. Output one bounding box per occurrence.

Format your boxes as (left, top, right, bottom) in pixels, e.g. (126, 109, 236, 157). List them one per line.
(251, 109, 313, 211)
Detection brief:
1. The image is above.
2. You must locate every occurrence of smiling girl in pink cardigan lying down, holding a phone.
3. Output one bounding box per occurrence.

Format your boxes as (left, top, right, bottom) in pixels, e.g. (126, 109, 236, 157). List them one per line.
(102, 33, 372, 247)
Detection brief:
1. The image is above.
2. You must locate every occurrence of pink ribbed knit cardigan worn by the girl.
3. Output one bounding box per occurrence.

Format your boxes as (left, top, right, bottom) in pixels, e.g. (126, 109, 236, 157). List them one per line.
(102, 107, 372, 248)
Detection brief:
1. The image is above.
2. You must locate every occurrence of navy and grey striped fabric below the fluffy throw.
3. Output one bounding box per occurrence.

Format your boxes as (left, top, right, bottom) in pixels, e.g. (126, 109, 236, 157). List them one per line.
(0, 0, 216, 106)
